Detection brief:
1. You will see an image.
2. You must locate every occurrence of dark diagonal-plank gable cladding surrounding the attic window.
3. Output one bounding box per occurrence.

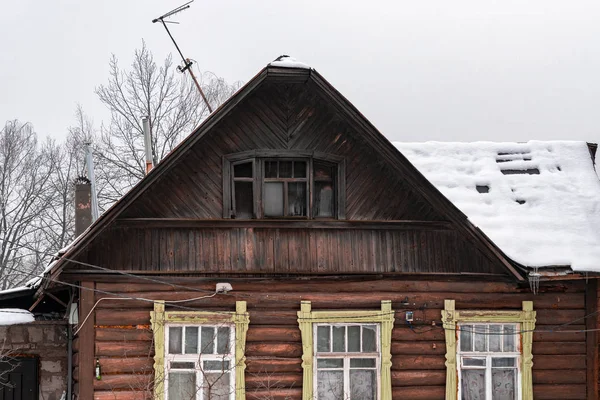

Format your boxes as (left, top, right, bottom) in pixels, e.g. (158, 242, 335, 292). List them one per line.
(122, 82, 442, 220)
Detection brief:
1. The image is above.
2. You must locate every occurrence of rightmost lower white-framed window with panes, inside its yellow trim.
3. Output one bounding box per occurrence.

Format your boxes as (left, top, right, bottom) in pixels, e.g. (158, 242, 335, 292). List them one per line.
(457, 323, 521, 400)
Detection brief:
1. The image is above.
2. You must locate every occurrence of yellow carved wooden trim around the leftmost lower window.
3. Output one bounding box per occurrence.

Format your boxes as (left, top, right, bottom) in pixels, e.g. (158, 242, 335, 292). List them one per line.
(150, 300, 250, 400)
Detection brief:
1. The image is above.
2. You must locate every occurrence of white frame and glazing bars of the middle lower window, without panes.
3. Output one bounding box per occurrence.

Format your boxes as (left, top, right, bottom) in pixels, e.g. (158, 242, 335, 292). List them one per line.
(313, 322, 381, 400)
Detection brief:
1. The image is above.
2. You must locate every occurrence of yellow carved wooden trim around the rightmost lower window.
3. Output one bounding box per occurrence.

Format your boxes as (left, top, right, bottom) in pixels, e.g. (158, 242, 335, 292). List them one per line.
(442, 300, 536, 400)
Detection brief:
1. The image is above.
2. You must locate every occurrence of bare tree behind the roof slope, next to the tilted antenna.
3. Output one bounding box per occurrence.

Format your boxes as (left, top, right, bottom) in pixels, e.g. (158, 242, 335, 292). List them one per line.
(96, 42, 238, 208)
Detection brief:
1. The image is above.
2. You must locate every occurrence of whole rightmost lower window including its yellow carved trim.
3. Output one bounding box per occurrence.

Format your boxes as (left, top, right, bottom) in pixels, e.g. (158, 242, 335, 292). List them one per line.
(442, 300, 535, 400)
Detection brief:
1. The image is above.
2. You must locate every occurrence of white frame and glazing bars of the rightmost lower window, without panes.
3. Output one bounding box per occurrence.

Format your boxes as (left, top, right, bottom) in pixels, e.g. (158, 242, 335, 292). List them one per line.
(456, 322, 523, 400)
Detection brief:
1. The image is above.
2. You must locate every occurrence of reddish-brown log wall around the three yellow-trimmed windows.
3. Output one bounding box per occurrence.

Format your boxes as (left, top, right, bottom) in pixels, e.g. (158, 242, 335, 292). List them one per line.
(85, 278, 587, 399)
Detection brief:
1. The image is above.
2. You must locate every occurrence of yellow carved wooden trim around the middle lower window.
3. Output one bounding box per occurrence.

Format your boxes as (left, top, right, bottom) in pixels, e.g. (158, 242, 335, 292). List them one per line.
(298, 300, 395, 400)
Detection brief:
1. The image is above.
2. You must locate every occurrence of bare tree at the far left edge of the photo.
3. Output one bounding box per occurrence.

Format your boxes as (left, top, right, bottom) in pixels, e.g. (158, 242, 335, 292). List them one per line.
(0, 120, 56, 290)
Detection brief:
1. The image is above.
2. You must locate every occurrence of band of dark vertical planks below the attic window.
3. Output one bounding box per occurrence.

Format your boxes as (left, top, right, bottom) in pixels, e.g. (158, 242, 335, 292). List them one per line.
(80, 227, 506, 275)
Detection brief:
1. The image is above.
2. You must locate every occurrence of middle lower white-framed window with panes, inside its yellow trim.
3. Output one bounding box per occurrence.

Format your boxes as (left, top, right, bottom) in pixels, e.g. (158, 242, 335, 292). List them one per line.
(314, 324, 381, 400)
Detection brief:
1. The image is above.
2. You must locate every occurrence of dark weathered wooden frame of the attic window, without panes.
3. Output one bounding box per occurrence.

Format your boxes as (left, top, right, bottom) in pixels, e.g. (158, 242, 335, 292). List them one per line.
(222, 149, 346, 219)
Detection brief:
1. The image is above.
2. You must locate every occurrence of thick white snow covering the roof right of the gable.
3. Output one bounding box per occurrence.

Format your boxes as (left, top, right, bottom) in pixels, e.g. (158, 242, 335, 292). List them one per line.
(394, 141, 600, 272)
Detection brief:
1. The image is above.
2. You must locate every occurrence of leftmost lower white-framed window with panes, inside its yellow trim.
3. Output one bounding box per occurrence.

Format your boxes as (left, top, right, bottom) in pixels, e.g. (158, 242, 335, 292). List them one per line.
(165, 324, 236, 400)
